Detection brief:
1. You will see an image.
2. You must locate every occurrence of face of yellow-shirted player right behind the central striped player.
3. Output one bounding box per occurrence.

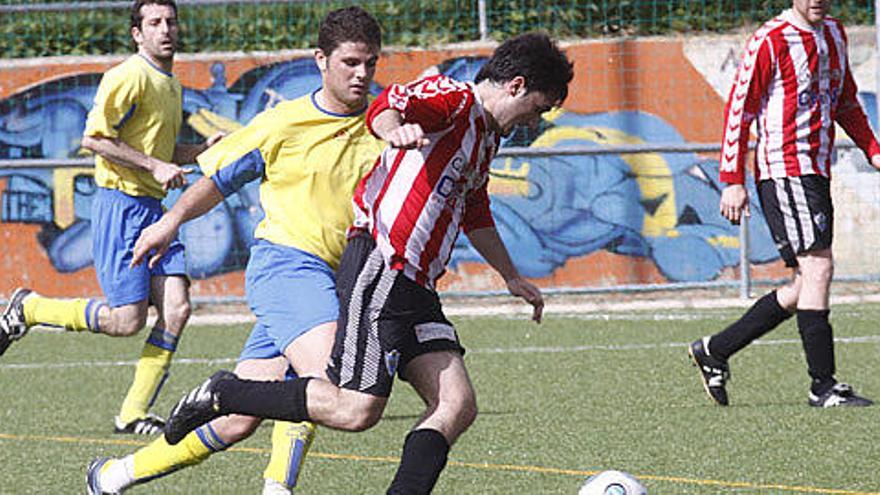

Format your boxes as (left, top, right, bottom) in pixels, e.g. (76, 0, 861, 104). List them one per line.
(315, 41, 379, 111)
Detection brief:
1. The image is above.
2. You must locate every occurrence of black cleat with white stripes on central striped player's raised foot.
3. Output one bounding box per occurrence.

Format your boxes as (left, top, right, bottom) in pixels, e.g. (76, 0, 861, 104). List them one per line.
(165, 370, 235, 445)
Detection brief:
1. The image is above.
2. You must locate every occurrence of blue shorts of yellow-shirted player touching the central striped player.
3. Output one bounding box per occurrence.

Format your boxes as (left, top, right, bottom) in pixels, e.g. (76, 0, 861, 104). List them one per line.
(238, 239, 339, 361)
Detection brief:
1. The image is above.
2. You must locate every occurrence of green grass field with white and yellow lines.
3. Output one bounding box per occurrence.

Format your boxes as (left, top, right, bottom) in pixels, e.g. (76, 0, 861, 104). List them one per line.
(0, 306, 880, 495)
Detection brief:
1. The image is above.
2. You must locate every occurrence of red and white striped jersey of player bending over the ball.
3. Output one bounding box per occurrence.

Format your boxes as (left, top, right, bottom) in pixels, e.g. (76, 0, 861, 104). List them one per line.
(353, 75, 500, 288)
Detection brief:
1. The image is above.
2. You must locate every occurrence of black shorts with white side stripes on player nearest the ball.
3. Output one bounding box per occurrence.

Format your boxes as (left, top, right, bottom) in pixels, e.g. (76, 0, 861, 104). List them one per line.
(327, 235, 464, 397)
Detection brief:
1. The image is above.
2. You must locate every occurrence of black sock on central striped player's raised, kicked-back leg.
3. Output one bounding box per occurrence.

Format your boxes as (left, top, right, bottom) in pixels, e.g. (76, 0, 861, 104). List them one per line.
(217, 378, 311, 422)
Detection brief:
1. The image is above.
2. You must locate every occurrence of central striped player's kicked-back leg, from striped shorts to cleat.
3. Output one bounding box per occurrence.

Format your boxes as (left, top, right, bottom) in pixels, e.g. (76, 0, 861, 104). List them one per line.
(165, 237, 393, 443)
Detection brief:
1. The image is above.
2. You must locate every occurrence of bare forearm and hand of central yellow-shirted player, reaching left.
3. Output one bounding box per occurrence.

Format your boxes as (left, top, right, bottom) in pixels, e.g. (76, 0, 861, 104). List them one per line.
(131, 177, 223, 268)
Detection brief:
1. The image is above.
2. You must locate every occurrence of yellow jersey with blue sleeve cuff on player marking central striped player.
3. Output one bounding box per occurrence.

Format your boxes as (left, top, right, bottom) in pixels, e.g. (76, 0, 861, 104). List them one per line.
(198, 93, 383, 269)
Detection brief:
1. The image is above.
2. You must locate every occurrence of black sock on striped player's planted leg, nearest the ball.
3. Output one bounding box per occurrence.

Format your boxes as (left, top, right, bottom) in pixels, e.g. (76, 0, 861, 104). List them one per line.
(387, 429, 449, 495)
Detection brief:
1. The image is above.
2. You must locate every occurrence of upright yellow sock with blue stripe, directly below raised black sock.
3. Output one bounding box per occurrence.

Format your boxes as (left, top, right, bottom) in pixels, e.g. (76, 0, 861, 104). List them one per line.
(263, 421, 315, 488)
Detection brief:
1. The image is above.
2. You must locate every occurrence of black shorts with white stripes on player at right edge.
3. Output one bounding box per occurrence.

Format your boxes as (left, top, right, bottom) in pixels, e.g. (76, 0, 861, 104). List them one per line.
(758, 175, 834, 268)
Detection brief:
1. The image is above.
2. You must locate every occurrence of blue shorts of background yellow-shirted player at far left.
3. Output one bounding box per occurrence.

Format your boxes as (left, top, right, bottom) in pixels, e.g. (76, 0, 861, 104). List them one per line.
(92, 187, 186, 308)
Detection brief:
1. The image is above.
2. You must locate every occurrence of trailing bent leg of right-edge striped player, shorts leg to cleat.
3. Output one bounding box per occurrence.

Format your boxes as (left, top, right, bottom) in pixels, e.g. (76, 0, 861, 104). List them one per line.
(688, 179, 800, 406)
